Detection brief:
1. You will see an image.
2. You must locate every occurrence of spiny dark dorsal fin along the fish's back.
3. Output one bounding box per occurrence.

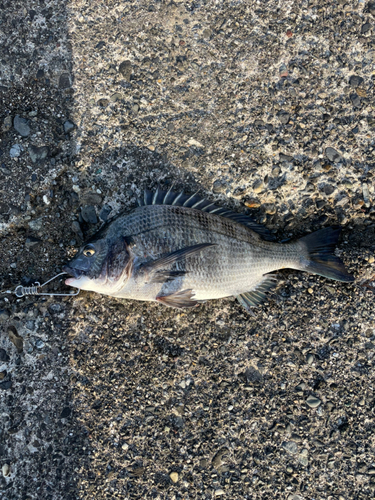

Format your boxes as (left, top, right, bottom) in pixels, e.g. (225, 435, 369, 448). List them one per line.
(138, 189, 276, 241)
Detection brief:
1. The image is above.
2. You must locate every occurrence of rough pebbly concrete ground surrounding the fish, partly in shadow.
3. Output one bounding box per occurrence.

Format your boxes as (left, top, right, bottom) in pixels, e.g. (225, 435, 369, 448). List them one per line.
(0, 0, 375, 500)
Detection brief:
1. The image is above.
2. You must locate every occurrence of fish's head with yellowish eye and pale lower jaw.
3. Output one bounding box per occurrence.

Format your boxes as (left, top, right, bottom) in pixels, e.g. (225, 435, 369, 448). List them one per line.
(63, 236, 132, 295)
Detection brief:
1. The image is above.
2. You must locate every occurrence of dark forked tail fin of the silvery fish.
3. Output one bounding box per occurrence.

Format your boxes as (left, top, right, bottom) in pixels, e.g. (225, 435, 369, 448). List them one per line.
(298, 227, 354, 281)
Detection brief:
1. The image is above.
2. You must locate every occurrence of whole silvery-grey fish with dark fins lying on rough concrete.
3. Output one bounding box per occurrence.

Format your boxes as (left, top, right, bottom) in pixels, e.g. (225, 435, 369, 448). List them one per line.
(63, 189, 354, 312)
